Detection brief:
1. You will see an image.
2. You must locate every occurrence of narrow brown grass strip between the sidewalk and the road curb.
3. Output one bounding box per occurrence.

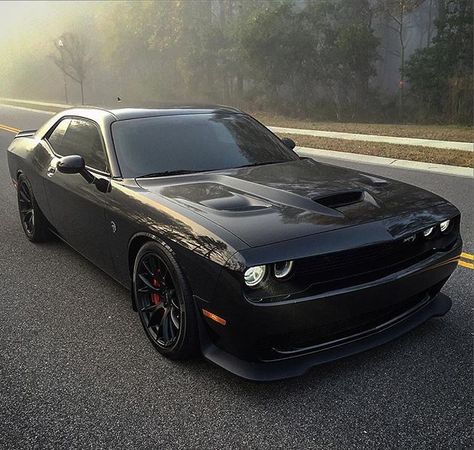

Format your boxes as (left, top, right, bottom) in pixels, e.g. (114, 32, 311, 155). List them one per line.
(278, 133, 474, 171)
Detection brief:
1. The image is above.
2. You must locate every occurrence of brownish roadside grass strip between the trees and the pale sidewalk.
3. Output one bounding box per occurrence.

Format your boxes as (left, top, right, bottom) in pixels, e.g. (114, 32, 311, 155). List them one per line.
(251, 112, 474, 142)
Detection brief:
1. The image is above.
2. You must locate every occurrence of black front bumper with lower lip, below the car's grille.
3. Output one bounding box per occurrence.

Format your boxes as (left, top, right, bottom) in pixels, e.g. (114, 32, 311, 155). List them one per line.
(198, 239, 462, 381)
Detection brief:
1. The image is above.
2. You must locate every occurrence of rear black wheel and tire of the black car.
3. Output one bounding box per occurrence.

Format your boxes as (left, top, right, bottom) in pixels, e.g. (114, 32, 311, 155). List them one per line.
(17, 174, 51, 242)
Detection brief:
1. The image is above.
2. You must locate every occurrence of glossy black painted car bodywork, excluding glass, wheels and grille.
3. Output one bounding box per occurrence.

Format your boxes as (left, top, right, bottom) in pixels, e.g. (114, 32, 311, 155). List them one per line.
(8, 108, 462, 380)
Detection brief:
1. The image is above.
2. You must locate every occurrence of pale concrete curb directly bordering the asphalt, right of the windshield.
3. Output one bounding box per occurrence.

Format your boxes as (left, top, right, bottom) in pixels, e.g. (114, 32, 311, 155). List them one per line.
(295, 147, 474, 178)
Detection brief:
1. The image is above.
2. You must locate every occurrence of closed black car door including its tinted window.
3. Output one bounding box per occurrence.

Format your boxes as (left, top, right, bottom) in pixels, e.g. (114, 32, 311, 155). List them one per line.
(45, 117, 111, 272)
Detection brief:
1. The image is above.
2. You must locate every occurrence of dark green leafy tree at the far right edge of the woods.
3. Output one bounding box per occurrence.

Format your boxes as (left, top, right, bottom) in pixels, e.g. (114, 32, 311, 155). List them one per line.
(406, 0, 473, 124)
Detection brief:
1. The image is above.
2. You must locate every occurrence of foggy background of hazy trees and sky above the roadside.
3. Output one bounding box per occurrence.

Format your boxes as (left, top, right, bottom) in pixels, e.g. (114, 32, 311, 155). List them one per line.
(0, 0, 472, 122)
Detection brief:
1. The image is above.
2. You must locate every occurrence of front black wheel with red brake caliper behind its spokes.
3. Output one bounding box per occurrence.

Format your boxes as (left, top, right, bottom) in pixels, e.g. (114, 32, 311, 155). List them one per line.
(132, 241, 199, 360)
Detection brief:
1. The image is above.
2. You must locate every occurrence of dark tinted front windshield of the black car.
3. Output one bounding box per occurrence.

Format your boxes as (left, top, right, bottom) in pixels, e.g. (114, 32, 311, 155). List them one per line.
(112, 113, 299, 178)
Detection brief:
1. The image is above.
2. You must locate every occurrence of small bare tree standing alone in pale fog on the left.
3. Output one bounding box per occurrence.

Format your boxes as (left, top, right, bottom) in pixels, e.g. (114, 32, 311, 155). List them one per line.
(52, 33, 91, 104)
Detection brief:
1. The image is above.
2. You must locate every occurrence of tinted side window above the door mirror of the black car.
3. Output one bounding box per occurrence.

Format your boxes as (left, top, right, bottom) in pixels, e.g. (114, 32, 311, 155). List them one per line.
(60, 119, 107, 172)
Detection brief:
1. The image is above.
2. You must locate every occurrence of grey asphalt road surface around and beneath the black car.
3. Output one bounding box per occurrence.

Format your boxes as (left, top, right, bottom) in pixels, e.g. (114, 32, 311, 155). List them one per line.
(0, 107, 474, 449)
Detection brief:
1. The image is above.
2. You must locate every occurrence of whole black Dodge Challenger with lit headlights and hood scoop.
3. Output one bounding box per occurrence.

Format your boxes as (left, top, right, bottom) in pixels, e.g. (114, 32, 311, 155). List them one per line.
(8, 107, 462, 380)
